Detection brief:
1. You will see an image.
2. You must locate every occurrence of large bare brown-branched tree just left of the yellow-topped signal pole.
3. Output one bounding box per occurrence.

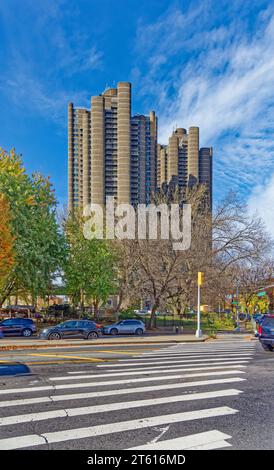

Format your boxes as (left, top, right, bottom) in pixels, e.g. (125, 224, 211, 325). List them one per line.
(127, 186, 211, 328)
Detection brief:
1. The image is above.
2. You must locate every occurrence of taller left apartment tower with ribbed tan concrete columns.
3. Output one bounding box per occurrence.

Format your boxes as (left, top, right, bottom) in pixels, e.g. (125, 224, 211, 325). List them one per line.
(68, 82, 157, 210)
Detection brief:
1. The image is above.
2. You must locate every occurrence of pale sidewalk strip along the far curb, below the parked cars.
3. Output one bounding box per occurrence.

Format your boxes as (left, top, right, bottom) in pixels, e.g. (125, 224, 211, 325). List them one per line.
(0, 333, 208, 351)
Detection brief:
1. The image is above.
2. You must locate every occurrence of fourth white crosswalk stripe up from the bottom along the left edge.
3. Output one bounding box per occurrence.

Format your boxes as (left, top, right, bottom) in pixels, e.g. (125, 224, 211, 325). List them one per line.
(0, 369, 245, 395)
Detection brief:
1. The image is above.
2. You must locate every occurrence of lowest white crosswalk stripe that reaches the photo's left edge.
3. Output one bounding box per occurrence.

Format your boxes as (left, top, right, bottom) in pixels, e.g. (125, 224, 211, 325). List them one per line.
(0, 406, 238, 450)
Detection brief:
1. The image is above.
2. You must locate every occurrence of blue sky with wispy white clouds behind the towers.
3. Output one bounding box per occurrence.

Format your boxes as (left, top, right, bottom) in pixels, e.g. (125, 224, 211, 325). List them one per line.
(0, 0, 274, 229)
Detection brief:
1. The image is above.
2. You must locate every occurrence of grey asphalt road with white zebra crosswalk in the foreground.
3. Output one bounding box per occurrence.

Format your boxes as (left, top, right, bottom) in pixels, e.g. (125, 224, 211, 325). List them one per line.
(0, 337, 274, 450)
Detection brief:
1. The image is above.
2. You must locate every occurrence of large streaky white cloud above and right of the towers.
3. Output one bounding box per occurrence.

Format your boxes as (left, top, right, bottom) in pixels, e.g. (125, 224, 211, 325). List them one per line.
(135, 1, 274, 224)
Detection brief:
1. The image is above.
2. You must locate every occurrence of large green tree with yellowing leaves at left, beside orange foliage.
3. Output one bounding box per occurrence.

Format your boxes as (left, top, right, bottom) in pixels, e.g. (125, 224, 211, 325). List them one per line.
(0, 150, 65, 305)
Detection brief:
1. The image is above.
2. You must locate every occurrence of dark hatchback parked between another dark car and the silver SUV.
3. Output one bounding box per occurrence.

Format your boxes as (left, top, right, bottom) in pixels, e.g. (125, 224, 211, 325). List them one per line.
(40, 320, 101, 340)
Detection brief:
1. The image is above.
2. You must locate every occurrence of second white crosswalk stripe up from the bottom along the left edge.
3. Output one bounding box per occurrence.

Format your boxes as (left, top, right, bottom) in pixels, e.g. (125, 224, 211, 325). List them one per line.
(0, 389, 242, 426)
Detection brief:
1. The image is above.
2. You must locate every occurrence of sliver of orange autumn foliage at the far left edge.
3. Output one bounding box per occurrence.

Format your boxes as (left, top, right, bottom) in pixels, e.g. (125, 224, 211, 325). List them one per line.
(0, 194, 14, 292)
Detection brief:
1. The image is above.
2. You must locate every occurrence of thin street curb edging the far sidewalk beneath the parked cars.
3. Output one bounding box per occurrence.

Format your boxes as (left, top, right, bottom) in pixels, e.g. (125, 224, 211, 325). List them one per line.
(0, 337, 209, 351)
